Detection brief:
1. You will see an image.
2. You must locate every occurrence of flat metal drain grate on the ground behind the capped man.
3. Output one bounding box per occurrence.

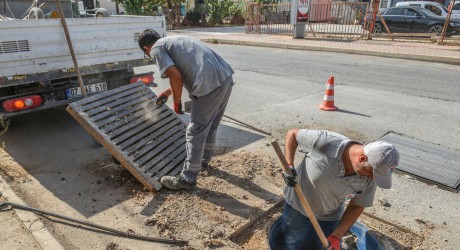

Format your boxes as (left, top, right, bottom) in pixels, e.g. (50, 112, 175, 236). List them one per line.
(380, 133, 460, 192)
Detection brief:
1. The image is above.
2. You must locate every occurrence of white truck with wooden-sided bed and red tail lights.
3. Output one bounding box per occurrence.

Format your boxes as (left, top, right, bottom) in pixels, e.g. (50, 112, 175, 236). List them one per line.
(0, 4, 166, 130)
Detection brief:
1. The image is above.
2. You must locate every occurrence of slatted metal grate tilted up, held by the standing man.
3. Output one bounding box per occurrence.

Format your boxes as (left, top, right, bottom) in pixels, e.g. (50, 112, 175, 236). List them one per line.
(67, 83, 186, 191)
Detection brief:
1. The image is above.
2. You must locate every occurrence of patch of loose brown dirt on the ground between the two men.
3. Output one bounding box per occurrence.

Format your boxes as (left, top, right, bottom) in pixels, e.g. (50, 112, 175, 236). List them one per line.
(141, 149, 283, 249)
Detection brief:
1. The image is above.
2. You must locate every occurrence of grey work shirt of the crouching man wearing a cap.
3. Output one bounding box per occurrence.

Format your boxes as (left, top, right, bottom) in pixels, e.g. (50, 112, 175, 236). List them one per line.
(284, 129, 376, 221)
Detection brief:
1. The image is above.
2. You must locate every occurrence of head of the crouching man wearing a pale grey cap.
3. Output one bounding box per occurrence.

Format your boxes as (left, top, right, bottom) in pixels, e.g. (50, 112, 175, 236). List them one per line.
(364, 141, 399, 189)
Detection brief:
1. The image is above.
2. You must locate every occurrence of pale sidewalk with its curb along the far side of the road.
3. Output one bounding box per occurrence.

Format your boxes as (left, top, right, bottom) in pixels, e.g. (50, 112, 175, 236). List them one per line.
(168, 27, 460, 65)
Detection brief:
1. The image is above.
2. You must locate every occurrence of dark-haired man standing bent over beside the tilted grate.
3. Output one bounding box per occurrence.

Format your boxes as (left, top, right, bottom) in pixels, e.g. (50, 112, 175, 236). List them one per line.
(138, 29, 234, 190)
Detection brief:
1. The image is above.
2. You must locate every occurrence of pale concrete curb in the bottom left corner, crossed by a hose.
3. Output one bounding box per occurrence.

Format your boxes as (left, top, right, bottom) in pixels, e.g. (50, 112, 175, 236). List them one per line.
(0, 176, 64, 250)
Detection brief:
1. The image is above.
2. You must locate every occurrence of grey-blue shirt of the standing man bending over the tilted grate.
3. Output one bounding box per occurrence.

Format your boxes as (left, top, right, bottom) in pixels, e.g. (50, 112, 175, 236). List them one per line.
(150, 36, 234, 97)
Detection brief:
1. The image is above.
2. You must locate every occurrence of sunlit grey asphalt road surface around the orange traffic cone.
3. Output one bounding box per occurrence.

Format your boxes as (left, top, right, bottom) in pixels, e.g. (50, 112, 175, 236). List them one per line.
(210, 43, 460, 150)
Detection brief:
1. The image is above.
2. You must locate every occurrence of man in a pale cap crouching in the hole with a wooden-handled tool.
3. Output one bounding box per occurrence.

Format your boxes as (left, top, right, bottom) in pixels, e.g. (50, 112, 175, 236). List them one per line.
(269, 129, 399, 250)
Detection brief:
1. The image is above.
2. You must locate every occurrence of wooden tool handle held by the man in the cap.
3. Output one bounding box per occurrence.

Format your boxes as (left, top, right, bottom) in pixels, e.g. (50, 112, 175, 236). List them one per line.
(271, 141, 329, 248)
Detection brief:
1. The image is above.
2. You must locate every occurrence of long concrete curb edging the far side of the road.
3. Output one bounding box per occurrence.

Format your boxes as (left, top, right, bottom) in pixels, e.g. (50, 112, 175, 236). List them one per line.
(201, 38, 460, 65)
